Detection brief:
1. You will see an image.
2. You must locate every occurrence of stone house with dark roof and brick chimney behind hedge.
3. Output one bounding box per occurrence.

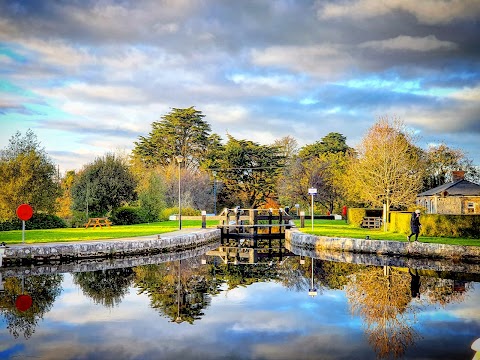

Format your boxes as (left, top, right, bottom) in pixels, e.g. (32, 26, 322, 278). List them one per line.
(417, 171, 480, 215)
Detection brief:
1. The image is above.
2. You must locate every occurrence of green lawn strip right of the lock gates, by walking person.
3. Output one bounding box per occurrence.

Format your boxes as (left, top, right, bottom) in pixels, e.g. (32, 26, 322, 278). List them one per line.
(295, 219, 480, 246)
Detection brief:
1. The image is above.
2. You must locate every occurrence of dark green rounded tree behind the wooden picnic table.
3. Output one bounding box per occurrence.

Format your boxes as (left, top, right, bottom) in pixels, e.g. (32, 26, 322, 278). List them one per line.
(72, 154, 137, 215)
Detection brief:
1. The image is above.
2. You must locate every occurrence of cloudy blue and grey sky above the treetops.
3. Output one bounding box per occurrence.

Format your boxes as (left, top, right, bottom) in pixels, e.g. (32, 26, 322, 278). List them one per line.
(0, 0, 480, 172)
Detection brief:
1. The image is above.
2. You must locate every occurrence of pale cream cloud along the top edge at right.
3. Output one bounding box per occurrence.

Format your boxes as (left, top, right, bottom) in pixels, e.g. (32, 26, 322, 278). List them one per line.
(317, 0, 480, 24)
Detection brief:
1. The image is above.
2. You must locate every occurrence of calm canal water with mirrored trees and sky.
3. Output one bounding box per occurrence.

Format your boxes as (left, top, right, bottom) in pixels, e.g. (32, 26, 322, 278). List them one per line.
(0, 239, 480, 360)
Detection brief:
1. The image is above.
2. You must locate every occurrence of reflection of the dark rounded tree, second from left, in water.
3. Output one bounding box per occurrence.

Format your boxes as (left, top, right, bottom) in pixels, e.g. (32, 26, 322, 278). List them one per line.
(73, 268, 133, 308)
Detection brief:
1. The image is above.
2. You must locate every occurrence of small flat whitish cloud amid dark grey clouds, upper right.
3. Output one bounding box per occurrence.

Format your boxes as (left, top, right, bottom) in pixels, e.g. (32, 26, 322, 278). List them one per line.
(359, 35, 457, 51)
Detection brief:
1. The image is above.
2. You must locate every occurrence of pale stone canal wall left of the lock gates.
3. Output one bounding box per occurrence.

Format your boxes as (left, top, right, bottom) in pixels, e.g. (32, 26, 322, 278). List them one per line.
(1, 229, 221, 266)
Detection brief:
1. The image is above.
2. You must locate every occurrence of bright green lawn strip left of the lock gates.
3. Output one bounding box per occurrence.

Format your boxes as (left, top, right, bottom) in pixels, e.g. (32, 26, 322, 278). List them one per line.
(0, 220, 218, 244)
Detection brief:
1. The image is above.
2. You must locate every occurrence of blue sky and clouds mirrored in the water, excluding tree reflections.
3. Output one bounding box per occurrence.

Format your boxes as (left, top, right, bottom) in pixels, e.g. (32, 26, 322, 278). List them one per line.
(0, 275, 480, 359)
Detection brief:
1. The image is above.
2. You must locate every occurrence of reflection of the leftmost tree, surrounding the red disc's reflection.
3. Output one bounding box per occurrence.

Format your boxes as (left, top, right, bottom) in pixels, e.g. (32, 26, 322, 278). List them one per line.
(0, 275, 63, 339)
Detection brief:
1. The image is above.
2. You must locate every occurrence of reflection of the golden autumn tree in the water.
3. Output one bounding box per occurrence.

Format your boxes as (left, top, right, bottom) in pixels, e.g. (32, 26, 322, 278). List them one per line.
(346, 267, 418, 358)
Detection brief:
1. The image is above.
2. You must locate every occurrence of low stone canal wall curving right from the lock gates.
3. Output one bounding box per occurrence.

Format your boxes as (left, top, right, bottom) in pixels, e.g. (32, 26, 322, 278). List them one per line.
(285, 229, 480, 261)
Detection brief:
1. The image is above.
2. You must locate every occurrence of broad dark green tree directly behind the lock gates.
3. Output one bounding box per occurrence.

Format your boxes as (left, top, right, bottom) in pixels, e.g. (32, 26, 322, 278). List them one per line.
(218, 135, 284, 208)
